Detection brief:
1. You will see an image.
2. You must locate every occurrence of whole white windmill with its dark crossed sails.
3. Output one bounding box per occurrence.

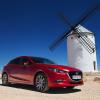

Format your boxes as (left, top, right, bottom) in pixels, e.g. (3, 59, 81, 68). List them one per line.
(49, 3, 100, 72)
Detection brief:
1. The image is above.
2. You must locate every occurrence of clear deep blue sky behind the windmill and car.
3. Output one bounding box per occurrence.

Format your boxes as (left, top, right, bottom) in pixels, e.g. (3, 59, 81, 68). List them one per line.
(0, 0, 100, 69)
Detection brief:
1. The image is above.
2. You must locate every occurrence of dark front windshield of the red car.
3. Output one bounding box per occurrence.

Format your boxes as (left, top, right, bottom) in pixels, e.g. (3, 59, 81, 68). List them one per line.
(31, 57, 55, 64)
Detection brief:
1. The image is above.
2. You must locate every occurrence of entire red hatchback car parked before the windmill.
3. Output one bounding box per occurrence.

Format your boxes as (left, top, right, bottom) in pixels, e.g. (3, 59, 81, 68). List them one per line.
(2, 56, 83, 92)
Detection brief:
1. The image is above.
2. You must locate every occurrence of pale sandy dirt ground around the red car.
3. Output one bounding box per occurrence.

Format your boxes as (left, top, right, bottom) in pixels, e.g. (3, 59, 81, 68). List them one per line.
(0, 74, 100, 100)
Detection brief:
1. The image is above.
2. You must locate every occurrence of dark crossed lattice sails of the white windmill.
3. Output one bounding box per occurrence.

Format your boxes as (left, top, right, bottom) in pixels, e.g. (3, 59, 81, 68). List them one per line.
(49, 3, 100, 53)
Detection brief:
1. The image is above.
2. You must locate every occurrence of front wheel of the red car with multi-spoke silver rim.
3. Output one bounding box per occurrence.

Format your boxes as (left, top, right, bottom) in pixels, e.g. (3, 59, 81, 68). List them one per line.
(35, 73, 49, 92)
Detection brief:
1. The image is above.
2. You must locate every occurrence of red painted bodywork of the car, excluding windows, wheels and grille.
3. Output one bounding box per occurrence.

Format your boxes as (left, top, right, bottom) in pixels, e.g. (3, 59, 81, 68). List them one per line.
(3, 56, 83, 88)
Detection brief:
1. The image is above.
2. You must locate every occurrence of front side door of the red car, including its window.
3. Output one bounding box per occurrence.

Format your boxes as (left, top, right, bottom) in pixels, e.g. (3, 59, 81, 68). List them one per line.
(17, 57, 33, 84)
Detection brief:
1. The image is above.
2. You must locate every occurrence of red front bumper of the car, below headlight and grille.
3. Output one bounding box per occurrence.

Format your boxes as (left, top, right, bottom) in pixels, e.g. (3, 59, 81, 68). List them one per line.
(48, 72, 83, 87)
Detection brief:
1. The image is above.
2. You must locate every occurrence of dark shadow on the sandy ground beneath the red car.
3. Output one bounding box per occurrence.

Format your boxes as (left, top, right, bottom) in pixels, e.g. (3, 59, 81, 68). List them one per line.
(0, 84, 81, 94)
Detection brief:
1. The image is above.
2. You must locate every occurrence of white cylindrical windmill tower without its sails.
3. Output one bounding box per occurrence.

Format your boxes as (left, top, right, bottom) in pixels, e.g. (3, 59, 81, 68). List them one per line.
(67, 25, 98, 72)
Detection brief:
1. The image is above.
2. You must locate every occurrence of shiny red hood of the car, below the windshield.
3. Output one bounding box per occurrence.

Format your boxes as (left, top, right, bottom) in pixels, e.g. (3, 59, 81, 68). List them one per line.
(36, 64, 80, 72)
